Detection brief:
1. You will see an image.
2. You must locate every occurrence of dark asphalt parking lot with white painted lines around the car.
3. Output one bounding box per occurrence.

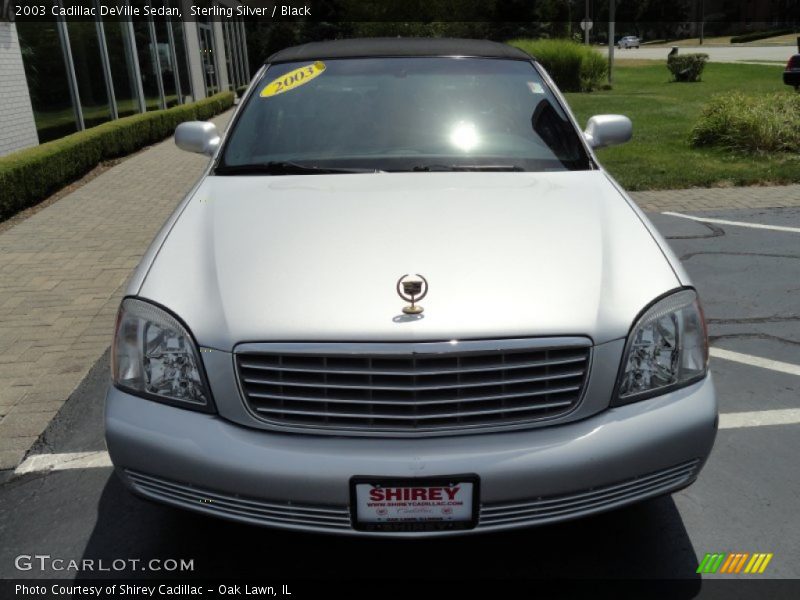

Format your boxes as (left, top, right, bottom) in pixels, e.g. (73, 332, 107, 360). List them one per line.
(0, 208, 800, 584)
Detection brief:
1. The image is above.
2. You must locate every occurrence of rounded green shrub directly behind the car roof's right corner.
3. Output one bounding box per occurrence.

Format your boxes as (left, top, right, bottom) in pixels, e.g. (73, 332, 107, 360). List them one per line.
(508, 40, 608, 92)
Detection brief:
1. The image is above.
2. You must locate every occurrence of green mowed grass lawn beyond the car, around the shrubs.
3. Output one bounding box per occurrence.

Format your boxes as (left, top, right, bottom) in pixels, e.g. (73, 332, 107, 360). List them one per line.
(566, 62, 800, 190)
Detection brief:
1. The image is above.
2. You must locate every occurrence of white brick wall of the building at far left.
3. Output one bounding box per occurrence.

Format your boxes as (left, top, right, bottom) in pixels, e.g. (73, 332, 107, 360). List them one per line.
(0, 22, 39, 156)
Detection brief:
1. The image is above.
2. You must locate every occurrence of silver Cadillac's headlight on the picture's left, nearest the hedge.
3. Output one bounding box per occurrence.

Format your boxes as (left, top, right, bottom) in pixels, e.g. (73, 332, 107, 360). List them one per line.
(111, 298, 211, 410)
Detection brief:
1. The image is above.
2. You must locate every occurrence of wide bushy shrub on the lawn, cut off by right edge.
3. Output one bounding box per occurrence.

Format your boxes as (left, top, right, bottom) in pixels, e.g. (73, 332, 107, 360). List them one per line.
(691, 92, 800, 153)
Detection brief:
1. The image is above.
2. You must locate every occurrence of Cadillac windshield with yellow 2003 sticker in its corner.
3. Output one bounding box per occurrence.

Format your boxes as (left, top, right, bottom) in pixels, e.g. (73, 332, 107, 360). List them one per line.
(216, 58, 591, 174)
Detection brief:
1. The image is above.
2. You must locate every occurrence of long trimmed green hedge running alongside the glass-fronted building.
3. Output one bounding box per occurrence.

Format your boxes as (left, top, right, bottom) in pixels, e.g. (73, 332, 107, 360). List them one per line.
(0, 92, 233, 221)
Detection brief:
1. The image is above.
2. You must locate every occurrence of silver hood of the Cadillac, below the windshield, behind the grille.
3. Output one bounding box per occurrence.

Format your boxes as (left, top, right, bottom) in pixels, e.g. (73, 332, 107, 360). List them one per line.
(139, 171, 680, 351)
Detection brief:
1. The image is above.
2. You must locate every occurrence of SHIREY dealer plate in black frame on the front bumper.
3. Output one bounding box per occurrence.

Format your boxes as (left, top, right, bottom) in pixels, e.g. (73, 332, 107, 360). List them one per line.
(351, 475, 478, 531)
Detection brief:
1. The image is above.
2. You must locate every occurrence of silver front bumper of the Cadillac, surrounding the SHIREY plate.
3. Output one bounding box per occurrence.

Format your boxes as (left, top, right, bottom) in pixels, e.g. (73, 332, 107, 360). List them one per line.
(106, 375, 717, 537)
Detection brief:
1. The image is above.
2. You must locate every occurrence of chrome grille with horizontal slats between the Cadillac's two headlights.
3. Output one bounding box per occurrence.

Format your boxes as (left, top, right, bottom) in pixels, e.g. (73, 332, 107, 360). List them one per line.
(236, 338, 590, 433)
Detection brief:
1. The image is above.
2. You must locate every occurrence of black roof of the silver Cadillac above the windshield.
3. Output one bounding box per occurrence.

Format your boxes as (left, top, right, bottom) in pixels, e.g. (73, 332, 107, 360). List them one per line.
(267, 38, 531, 63)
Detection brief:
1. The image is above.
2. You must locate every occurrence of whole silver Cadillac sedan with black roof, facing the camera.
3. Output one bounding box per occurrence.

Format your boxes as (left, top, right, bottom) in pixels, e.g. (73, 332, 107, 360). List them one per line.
(105, 39, 717, 537)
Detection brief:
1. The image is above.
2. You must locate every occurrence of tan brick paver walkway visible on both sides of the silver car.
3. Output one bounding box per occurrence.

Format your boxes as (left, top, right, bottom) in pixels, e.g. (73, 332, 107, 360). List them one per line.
(0, 124, 800, 470)
